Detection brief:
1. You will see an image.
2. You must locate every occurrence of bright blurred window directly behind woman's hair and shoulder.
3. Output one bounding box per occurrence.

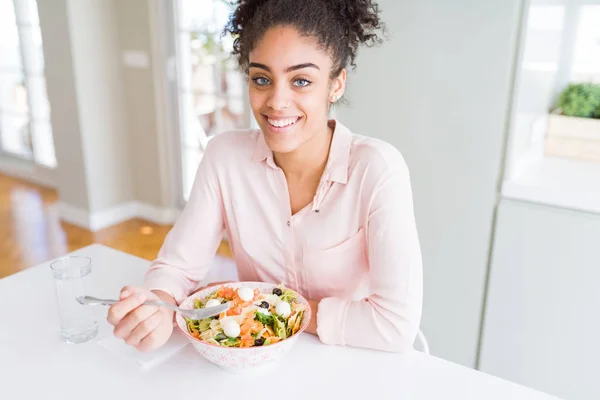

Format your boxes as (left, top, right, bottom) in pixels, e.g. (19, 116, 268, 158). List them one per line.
(174, 0, 250, 200)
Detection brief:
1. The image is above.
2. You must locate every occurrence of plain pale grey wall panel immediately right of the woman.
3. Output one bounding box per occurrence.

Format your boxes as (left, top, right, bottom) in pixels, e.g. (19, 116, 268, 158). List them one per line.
(337, 0, 522, 366)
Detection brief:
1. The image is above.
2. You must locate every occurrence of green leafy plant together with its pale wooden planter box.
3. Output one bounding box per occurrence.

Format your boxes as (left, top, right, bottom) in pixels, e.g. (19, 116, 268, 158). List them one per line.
(546, 83, 600, 162)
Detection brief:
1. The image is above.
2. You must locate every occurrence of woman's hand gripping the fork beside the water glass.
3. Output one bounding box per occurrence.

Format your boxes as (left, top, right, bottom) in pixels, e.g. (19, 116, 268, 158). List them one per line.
(107, 286, 176, 351)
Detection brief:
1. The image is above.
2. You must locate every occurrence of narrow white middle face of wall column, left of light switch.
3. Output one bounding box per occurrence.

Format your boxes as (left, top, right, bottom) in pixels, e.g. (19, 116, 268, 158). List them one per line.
(67, 0, 134, 213)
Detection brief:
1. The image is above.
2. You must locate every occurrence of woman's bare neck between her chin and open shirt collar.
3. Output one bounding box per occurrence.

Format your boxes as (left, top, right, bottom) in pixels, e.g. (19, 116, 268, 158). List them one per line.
(273, 120, 333, 180)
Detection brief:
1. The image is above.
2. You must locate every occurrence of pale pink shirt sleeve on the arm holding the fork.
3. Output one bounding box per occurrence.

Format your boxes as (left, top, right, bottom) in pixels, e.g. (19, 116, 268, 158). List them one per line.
(144, 140, 224, 303)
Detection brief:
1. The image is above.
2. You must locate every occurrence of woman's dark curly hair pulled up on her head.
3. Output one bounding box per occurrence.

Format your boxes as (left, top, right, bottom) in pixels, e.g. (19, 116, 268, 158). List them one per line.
(225, 0, 385, 78)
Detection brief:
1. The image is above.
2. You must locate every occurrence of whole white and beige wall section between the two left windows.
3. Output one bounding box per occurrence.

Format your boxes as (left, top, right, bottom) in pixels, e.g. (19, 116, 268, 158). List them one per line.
(33, 0, 178, 230)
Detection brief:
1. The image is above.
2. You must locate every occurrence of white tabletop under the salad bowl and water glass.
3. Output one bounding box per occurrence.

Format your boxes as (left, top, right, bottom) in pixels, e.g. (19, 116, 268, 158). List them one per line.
(0, 245, 556, 400)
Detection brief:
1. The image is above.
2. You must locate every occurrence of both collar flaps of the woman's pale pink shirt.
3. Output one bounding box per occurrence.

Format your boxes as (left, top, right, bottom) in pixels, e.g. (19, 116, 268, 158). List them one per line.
(252, 120, 352, 184)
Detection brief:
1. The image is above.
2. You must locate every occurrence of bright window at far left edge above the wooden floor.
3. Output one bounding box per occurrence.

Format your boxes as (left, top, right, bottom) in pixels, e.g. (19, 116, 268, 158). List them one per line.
(0, 0, 56, 168)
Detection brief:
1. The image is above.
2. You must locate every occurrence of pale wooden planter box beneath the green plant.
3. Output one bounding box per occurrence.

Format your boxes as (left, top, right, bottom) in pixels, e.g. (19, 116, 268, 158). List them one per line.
(545, 114, 600, 163)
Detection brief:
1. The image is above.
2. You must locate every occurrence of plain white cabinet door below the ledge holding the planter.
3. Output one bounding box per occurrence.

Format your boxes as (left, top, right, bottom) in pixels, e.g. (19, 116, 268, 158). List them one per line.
(480, 200, 600, 399)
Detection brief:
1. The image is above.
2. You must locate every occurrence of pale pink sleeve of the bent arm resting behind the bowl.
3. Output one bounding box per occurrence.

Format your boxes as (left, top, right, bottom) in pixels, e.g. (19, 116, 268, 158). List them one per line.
(317, 162, 423, 352)
